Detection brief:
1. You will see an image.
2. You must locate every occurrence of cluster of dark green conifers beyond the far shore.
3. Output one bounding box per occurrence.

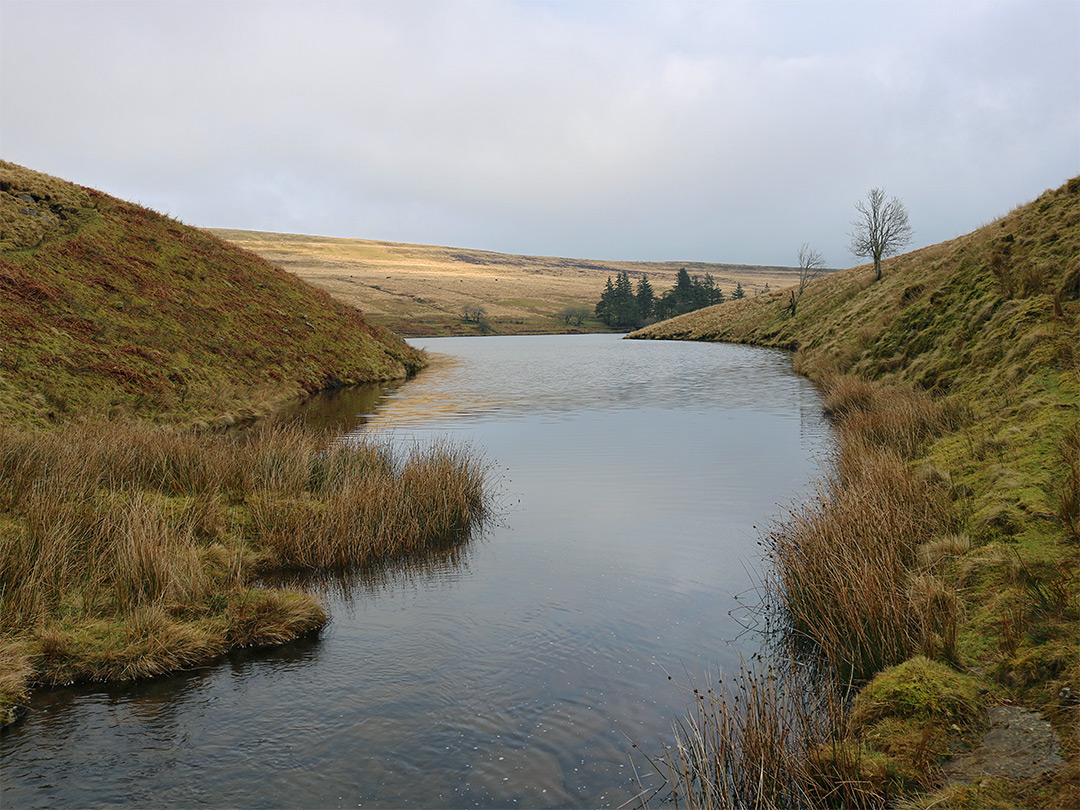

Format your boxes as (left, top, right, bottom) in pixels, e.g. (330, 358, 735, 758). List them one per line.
(595, 268, 746, 329)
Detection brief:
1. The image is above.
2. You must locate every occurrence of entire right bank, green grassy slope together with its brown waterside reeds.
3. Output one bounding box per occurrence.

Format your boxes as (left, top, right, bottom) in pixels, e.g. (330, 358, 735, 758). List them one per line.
(632, 178, 1080, 808)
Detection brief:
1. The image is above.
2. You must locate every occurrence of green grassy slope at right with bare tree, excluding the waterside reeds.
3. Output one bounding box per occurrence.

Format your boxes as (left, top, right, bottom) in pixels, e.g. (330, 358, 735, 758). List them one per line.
(631, 178, 1080, 806)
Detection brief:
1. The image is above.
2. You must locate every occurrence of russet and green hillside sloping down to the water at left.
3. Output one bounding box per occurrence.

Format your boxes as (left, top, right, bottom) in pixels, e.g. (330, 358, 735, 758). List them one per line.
(0, 162, 422, 421)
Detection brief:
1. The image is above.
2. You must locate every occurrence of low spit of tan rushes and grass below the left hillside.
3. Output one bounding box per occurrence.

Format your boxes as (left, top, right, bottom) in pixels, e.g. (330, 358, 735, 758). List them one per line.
(0, 422, 485, 719)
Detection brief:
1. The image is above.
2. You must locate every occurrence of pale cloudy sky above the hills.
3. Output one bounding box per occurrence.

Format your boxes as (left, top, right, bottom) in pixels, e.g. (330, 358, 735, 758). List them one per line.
(0, 0, 1080, 267)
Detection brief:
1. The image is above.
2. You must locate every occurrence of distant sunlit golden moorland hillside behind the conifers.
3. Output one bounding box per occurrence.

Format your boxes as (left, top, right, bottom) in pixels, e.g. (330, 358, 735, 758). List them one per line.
(214, 230, 812, 336)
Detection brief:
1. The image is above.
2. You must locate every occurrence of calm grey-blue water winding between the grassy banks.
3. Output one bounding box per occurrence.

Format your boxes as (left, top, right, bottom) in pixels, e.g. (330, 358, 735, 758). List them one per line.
(0, 336, 828, 808)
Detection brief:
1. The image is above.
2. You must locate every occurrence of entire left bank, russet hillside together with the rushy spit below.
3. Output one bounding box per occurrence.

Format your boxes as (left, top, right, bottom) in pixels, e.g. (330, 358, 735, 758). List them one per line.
(0, 162, 485, 725)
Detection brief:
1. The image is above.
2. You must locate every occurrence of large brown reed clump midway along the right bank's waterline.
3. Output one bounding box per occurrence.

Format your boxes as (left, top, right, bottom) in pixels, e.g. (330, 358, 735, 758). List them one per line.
(768, 443, 959, 680)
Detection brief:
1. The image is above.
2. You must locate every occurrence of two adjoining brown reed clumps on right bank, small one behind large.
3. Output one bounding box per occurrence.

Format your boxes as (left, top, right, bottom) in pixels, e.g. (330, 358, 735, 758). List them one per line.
(768, 379, 961, 680)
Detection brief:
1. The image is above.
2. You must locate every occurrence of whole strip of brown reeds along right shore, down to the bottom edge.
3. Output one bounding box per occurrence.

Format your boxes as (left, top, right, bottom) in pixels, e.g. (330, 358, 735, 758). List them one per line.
(644, 378, 967, 810)
